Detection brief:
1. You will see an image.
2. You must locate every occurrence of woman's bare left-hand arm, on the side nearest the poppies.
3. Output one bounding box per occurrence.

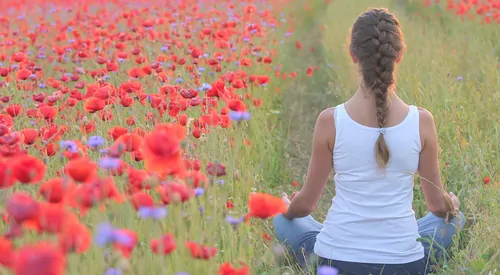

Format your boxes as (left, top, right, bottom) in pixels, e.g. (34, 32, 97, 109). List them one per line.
(284, 108, 335, 219)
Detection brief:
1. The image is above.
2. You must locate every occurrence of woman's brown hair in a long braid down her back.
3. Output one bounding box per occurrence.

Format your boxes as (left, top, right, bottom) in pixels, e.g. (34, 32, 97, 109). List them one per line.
(350, 8, 405, 169)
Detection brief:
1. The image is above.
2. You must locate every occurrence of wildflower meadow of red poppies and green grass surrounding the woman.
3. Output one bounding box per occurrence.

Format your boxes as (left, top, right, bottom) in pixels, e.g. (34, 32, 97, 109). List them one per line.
(0, 0, 500, 275)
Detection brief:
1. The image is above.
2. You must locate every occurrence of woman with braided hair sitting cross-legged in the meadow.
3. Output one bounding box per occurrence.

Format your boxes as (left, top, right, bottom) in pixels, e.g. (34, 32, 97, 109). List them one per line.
(274, 9, 465, 275)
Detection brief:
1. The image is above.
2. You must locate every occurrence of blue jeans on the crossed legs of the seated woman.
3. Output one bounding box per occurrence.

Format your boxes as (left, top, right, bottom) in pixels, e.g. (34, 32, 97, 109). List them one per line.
(273, 212, 465, 275)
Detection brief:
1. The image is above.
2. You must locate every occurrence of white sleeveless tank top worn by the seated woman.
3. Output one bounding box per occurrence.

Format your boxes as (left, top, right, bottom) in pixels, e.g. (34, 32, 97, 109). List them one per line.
(314, 104, 424, 264)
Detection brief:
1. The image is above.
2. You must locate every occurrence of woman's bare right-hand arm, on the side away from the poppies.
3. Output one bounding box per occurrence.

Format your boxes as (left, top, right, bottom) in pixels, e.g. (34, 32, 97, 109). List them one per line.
(418, 109, 455, 218)
